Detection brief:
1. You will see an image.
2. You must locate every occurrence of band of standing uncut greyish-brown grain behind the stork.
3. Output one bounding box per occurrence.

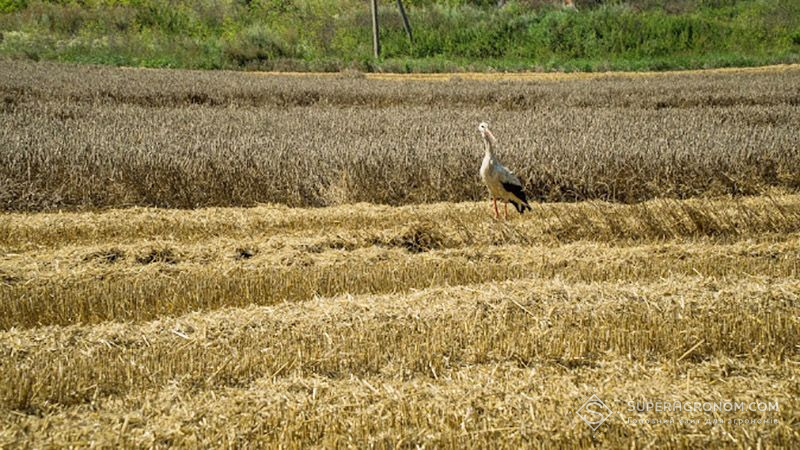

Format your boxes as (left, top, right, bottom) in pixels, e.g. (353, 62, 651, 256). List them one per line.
(0, 61, 800, 210)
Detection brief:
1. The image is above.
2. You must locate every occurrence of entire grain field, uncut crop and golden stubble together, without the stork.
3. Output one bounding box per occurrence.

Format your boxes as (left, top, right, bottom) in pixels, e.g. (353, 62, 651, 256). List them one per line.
(0, 62, 800, 448)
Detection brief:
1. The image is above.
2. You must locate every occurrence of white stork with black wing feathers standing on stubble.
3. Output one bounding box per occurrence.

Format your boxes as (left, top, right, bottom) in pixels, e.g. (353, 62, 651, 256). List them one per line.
(478, 122, 531, 219)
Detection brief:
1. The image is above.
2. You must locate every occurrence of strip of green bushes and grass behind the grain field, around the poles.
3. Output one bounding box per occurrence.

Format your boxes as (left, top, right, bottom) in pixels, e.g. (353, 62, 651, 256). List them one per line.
(0, 0, 800, 72)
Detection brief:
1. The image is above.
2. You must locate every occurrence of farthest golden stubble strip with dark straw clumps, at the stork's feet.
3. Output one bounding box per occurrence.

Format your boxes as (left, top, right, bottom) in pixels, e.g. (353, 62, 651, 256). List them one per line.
(0, 196, 800, 329)
